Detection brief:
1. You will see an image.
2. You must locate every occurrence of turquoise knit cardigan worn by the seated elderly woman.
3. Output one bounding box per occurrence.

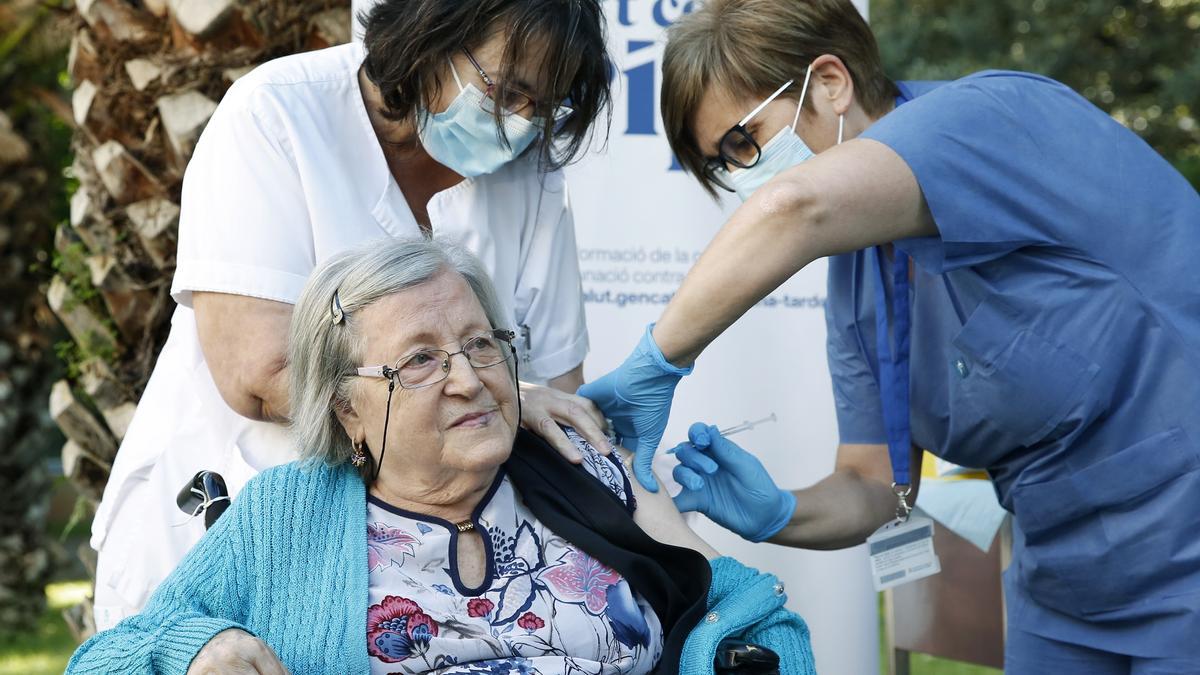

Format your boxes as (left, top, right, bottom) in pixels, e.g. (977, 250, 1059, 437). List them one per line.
(67, 462, 814, 675)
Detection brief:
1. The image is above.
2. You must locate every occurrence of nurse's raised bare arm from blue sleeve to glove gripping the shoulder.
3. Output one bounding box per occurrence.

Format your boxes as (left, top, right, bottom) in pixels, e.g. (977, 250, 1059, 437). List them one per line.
(654, 139, 937, 365)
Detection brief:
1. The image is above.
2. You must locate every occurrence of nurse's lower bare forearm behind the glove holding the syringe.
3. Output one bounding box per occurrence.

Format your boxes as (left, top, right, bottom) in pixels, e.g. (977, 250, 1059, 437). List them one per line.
(769, 471, 896, 550)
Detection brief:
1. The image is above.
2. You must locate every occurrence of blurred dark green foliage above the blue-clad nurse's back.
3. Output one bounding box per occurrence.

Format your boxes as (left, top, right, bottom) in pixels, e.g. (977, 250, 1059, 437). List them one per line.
(870, 0, 1200, 189)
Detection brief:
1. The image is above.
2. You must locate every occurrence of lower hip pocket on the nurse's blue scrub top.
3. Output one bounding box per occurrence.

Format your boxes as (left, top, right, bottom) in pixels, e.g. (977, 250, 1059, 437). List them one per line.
(1012, 428, 1200, 616)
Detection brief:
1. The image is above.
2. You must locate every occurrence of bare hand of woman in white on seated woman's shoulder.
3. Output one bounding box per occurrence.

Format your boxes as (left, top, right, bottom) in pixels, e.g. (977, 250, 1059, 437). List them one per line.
(521, 382, 612, 464)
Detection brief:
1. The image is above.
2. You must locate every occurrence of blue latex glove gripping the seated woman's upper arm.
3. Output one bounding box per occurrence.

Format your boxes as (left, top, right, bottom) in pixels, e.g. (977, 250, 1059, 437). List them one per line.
(578, 323, 692, 492)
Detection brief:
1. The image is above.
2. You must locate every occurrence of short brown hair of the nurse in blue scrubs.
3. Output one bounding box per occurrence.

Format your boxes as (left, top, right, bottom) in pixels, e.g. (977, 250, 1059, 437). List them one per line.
(661, 0, 898, 196)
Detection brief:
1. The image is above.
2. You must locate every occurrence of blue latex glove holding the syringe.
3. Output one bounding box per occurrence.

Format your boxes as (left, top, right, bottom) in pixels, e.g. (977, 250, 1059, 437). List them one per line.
(668, 422, 796, 542)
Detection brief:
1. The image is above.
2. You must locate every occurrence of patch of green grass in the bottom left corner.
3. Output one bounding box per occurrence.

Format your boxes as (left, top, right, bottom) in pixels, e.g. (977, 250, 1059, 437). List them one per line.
(0, 581, 91, 675)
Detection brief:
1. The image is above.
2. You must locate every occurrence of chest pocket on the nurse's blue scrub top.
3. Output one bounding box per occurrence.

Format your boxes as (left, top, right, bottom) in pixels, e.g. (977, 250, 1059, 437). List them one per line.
(953, 298, 1099, 447)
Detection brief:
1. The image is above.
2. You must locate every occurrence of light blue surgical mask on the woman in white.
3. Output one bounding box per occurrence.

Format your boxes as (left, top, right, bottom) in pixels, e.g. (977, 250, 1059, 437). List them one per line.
(418, 64, 539, 178)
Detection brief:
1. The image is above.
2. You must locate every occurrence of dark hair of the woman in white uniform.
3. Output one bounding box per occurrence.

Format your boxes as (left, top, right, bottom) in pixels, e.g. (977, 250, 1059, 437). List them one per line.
(359, 0, 611, 171)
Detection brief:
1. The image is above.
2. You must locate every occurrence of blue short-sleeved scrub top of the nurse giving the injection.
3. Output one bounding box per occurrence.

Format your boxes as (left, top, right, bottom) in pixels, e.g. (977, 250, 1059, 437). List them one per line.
(827, 71, 1200, 656)
